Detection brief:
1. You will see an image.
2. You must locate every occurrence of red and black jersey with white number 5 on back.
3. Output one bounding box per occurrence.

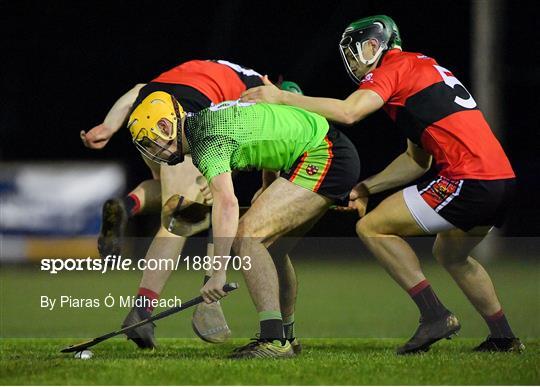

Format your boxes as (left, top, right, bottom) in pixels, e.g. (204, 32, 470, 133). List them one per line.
(359, 49, 515, 180)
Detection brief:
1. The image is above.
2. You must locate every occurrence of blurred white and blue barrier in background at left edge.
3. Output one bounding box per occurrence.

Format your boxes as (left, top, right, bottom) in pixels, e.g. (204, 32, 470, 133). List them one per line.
(0, 161, 126, 262)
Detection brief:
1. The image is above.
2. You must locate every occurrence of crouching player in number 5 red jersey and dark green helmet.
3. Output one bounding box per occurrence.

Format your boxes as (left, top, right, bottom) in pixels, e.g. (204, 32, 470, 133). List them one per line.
(242, 15, 524, 354)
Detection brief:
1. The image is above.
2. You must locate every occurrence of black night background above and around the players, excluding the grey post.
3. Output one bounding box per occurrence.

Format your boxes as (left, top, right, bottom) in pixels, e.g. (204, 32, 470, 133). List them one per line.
(0, 0, 540, 235)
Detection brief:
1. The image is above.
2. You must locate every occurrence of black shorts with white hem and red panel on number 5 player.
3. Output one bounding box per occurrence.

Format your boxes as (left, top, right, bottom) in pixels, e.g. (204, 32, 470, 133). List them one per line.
(403, 176, 516, 234)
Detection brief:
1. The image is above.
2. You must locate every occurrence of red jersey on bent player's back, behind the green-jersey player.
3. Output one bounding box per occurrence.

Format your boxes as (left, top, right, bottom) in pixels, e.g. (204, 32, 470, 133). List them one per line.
(152, 60, 262, 104)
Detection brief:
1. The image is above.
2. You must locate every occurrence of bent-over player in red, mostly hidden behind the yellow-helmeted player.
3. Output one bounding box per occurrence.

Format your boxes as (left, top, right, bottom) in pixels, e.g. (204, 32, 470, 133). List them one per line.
(80, 60, 268, 348)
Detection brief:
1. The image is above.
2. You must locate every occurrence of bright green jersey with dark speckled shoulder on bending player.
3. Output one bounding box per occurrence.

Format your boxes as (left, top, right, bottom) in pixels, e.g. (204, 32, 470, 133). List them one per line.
(185, 101, 329, 181)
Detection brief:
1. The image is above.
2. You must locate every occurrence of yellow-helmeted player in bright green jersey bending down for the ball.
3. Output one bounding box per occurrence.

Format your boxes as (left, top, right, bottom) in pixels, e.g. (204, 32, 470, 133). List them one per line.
(128, 92, 360, 358)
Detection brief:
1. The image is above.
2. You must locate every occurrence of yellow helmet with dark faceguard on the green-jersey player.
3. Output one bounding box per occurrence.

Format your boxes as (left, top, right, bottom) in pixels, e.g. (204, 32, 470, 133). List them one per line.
(127, 91, 186, 165)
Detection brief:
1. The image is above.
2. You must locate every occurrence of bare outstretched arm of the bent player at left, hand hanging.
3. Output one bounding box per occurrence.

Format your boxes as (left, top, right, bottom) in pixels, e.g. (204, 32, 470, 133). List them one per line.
(80, 83, 145, 149)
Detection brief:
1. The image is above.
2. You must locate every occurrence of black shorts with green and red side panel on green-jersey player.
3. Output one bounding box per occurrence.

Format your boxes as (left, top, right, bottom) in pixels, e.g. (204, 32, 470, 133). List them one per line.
(281, 125, 360, 205)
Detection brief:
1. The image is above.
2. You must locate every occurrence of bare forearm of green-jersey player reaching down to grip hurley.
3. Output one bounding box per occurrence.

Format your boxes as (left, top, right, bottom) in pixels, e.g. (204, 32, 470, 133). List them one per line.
(201, 172, 239, 303)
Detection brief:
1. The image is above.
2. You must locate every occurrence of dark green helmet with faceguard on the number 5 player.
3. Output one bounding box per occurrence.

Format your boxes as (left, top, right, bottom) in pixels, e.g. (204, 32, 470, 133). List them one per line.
(339, 15, 401, 83)
